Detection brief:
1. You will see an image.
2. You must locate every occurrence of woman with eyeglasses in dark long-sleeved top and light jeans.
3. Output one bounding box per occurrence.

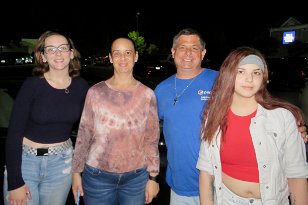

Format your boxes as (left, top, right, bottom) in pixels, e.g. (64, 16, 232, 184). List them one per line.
(3, 31, 89, 205)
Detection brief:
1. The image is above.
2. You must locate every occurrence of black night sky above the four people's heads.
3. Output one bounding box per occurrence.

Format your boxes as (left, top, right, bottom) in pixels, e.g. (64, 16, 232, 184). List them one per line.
(0, 0, 308, 60)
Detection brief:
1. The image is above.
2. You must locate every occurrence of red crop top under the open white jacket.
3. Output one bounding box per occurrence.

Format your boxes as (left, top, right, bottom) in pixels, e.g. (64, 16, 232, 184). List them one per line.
(220, 110, 259, 183)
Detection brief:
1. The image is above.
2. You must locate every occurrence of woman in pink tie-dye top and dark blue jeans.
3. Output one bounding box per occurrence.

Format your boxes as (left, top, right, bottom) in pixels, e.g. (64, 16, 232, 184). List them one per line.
(72, 38, 160, 205)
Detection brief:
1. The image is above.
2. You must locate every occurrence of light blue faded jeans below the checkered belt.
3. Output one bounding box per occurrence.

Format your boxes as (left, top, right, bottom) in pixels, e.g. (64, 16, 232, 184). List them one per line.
(3, 147, 73, 205)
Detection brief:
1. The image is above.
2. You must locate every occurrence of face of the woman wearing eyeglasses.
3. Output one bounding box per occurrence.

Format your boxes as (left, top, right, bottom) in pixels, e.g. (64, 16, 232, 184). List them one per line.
(41, 35, 74, 70)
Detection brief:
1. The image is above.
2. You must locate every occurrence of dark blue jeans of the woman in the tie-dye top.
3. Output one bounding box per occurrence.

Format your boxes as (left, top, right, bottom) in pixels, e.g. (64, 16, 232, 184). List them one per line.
(82, 164, 148, 205)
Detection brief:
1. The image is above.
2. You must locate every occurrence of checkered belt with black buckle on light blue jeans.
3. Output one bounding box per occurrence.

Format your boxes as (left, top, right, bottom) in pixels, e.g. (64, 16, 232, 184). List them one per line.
(23, 139, 73, 156)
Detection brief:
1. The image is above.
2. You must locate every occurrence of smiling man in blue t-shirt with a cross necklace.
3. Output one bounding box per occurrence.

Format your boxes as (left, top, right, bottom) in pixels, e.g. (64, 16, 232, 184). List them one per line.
(155, 28, 217, 205)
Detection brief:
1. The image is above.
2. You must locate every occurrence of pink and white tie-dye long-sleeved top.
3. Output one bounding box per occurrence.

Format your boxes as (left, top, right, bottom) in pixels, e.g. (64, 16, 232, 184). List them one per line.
(73, 81, 160, 173)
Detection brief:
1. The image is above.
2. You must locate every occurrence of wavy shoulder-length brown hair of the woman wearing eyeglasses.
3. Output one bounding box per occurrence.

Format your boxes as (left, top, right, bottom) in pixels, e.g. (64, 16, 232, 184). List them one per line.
(32, 31, 81, 77)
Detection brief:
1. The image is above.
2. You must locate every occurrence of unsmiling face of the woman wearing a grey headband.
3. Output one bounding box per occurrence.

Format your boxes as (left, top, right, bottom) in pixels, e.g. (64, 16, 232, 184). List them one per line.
(234, 64, 263, 99)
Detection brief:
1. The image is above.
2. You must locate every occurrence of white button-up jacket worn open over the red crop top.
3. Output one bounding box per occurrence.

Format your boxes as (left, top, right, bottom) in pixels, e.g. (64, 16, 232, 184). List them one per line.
(197, 105, 308, 205)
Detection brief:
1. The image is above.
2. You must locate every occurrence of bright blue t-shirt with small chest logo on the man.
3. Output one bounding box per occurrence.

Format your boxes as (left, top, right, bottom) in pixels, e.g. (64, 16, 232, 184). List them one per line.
(155, 69, 218, 196)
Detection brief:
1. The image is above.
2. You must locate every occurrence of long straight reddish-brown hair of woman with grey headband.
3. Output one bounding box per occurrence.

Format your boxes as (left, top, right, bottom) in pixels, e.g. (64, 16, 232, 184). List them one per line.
(201, 47, 304, 142)
